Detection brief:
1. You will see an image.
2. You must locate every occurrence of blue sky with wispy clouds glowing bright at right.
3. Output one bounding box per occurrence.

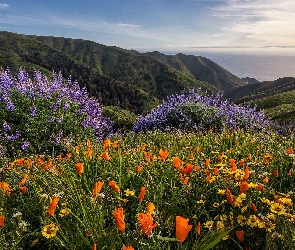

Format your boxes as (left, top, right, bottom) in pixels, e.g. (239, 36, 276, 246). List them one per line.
(0, 0, 295, 51)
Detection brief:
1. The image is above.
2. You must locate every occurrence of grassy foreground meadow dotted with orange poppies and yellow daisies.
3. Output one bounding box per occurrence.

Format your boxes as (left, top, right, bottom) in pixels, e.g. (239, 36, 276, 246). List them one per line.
(0, 131, 295, 249)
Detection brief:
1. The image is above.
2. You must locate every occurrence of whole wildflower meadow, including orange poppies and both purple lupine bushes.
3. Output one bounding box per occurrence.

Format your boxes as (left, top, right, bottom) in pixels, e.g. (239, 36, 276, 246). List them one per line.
(0, 70, 295, 250)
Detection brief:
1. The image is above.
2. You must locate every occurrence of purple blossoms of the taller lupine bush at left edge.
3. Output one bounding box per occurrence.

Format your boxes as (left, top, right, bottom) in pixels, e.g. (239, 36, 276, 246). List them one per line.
(0, 69, 112, 154)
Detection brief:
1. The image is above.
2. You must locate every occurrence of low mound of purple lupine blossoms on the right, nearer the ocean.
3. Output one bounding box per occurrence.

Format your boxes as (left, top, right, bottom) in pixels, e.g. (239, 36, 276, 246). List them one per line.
(133, 89, 270, 133)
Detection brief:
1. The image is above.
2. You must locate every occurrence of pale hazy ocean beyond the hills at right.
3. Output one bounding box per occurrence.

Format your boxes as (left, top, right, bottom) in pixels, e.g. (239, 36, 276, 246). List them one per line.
(168, 47, 295, 81)
